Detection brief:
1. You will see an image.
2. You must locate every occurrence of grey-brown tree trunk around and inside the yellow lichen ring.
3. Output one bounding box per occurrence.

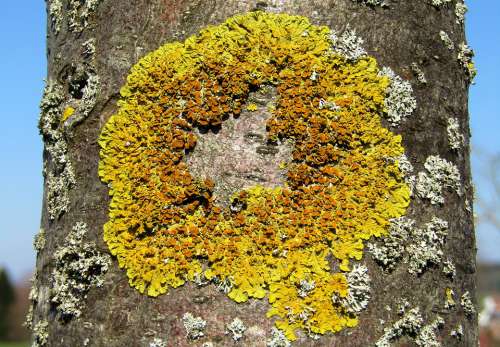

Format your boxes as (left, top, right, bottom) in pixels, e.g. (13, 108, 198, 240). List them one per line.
(27, 0, 477, 346)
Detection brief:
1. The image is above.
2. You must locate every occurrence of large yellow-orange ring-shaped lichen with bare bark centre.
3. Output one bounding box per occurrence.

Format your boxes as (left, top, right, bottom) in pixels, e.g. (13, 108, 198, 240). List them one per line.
(99, 12, 409, 340)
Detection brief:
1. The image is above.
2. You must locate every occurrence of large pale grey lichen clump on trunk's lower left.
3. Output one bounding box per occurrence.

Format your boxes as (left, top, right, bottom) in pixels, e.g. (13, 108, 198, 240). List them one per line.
(51, 222, 110, 319)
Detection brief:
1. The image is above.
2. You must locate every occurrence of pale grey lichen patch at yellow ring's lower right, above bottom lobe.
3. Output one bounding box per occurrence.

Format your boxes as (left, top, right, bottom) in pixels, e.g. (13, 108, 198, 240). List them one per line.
(368, 217, 415, 271)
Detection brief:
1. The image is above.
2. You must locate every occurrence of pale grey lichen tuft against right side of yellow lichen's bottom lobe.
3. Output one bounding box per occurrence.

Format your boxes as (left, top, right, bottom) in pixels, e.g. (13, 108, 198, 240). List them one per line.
(332, 264, 370, 314)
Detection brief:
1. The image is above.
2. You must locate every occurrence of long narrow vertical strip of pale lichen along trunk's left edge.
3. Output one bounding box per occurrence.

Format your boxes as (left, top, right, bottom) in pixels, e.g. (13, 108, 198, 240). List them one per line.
(39, 81, 76, 220)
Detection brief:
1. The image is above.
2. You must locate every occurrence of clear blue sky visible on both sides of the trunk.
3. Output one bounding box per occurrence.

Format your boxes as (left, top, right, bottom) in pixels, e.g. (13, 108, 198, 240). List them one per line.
(0, 0, 500, 279)
